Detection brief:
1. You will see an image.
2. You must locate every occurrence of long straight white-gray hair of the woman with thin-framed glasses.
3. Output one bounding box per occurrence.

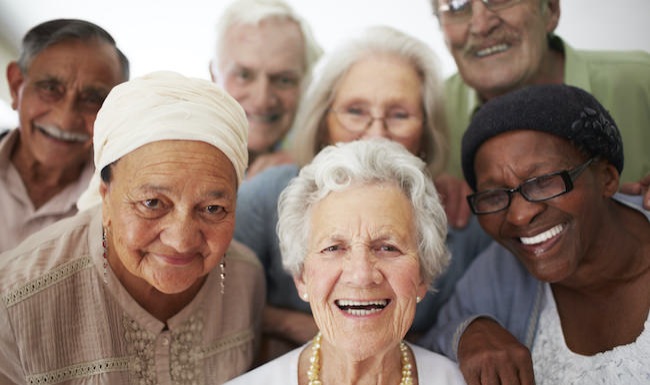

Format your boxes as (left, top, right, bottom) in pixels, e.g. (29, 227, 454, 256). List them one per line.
(291, 26, 449, 177)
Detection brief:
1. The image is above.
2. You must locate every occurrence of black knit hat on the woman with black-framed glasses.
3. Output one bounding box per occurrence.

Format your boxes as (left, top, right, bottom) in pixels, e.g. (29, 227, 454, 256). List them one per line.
(462, 84, 623, 191)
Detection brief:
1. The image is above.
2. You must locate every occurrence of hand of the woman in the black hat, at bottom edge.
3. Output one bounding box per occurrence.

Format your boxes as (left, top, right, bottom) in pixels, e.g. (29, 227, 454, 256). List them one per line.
(458, 318, 535, 385)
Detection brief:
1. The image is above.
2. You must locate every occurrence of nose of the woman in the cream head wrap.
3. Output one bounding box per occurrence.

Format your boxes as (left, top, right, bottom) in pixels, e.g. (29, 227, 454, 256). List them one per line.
(160, 210, 204, 254)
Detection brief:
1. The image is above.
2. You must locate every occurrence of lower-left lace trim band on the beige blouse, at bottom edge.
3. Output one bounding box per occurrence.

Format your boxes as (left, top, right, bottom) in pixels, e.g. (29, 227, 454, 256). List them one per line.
(27, 358, 129, 384)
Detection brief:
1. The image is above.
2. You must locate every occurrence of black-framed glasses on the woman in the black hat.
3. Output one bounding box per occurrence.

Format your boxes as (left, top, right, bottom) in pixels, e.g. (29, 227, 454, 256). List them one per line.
(467, 158, 596, 215)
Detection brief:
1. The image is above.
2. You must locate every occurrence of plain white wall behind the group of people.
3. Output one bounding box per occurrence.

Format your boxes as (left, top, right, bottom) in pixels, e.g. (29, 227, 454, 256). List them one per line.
(0, 0, 650, 127)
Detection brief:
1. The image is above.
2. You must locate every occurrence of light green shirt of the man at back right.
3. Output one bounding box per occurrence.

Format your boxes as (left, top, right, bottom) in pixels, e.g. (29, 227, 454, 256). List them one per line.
(445, 36, 650, 182)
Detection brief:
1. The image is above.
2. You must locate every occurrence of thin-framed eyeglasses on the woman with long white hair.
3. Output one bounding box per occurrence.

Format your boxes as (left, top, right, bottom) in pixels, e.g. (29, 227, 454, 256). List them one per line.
(330, 108, 422, 137)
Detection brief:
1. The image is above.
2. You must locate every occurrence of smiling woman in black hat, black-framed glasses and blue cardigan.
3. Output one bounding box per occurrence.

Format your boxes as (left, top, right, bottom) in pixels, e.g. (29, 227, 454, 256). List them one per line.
(420, 85, 650, 385)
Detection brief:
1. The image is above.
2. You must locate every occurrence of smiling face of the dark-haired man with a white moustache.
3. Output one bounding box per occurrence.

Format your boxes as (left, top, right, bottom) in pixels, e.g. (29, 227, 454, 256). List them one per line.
(7, 40, 123, 169)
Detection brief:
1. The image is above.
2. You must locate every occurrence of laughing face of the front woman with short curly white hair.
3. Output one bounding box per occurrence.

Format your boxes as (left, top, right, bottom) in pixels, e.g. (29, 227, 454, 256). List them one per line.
(295, 185, 427, 360)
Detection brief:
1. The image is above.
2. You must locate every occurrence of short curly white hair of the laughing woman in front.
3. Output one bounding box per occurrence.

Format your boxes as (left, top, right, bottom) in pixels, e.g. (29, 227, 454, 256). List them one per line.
(277, 138, 450, 284)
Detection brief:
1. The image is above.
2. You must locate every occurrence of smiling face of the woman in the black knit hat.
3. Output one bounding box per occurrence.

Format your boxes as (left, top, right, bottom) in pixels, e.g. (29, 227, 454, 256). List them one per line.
(474, 130, 606, 282)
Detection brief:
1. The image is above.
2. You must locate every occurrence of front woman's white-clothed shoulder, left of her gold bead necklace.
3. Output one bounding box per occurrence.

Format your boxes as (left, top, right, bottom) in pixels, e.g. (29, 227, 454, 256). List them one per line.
(225, 346, 304, 385)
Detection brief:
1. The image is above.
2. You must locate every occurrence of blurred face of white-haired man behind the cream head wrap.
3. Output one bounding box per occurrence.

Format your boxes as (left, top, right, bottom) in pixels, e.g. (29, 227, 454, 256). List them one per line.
(213, 19, 306, 154)
